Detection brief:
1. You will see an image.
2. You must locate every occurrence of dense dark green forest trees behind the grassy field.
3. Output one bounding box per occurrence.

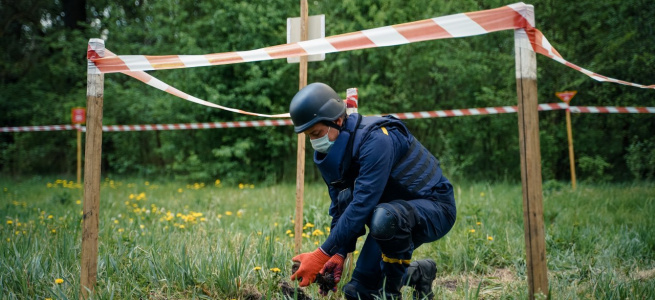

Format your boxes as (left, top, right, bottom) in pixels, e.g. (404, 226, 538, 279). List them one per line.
(0, 0, 655, 184)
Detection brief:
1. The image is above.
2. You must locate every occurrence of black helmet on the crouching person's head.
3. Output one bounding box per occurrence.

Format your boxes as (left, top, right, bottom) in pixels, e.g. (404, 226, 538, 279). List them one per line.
(289, 82, 346, 133)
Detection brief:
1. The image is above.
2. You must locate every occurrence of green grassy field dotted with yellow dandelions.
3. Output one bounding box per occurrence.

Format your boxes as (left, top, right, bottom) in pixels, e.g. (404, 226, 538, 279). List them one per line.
(0, 178, 655, 299)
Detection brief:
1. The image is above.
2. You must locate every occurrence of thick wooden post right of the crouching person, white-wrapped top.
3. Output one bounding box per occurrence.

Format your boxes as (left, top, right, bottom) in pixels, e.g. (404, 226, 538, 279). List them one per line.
(514, 5, 548, 299)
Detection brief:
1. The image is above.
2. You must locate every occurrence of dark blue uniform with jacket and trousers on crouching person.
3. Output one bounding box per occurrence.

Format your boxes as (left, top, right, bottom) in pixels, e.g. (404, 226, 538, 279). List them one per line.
(314, 114, 456, 293)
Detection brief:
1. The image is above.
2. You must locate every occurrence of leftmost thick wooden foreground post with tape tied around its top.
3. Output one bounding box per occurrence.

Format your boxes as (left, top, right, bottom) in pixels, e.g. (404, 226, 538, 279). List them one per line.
(80, 39, 105, 299)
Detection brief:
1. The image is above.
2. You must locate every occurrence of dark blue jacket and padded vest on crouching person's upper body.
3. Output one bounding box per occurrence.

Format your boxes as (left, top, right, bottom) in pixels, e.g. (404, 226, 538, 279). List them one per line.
(314, 114, 453, 255)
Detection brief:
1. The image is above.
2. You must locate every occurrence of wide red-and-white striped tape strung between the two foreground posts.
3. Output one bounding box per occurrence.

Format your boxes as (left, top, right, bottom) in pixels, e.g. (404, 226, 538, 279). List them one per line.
(87, 2, 655, 118)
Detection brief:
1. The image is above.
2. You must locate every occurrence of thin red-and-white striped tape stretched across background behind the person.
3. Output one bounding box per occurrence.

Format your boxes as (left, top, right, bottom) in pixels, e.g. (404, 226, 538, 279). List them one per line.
(0, 103, 655, 132)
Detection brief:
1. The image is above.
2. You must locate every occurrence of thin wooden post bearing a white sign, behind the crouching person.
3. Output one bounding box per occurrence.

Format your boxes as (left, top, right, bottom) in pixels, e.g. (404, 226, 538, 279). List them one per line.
(294, 0, 309, 254)
